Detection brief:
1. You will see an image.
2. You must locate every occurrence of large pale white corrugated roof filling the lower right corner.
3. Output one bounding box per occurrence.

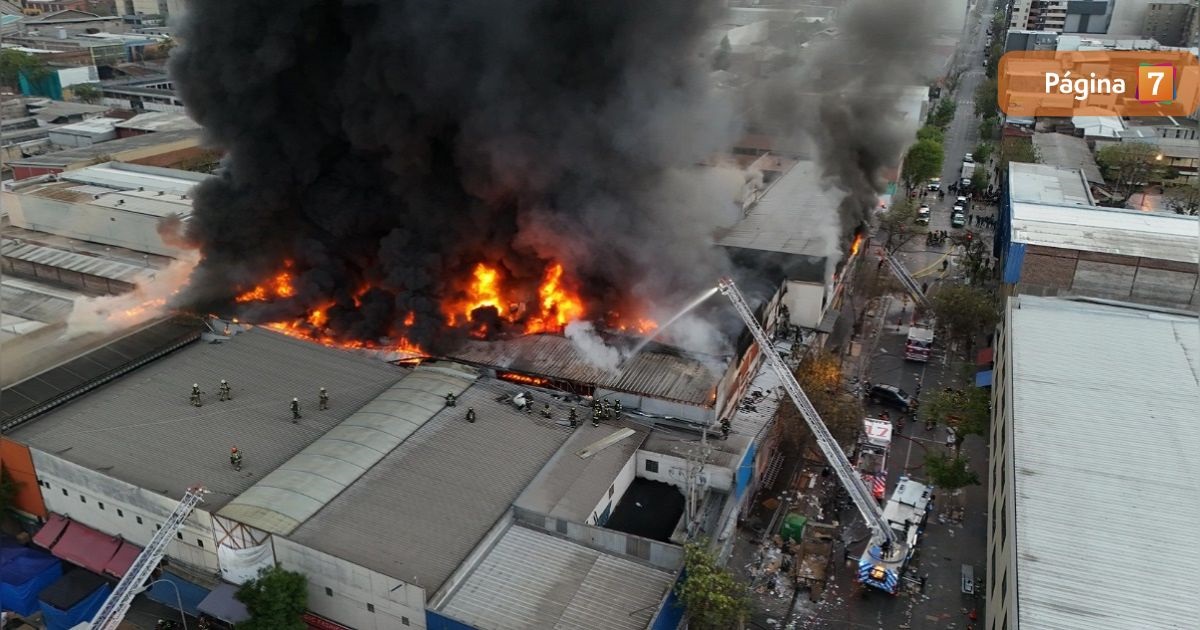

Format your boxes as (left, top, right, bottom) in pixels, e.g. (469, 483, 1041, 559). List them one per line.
(1008, 295, 1200, 630)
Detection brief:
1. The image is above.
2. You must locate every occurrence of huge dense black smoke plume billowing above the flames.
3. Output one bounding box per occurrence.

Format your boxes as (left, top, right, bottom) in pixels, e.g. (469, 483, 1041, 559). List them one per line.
(170, 0, 737, 348)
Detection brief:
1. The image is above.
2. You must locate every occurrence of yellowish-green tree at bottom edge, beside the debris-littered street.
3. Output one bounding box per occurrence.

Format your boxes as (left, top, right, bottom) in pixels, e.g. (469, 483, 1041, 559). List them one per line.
(676, 540, 750, 630)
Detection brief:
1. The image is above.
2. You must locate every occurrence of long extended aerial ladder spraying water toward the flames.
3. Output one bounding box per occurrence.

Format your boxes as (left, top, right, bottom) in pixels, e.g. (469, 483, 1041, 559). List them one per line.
(718, 278, 916, 578)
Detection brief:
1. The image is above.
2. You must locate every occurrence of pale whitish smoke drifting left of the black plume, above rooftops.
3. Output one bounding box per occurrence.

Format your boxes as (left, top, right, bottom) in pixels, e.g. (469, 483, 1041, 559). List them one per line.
(62, 251, 200, 340)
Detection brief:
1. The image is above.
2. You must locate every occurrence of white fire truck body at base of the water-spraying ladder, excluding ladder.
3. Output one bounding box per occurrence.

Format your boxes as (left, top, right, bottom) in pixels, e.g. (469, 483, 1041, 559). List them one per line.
(858, 476, 934, 595)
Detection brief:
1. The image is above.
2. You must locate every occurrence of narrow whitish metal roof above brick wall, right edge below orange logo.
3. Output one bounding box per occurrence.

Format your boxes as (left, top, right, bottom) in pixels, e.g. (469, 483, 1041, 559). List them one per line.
(1012, 203, 1200, 263)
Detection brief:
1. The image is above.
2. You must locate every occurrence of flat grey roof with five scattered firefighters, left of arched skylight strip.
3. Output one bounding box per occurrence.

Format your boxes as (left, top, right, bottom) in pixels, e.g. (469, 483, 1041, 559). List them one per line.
(11, 329, 406, 510)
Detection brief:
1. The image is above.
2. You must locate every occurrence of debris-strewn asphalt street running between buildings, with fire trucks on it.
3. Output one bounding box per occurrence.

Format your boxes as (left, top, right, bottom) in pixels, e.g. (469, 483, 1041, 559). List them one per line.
(790, 0, 991, 629)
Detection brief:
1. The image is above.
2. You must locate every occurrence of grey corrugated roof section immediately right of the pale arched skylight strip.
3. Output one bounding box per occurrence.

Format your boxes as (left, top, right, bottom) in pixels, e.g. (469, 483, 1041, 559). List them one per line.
(289, 378, 571, 594)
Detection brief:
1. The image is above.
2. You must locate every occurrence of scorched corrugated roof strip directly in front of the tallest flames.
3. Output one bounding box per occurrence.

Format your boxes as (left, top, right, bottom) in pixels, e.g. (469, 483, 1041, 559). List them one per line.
(450, 335, 725, 407)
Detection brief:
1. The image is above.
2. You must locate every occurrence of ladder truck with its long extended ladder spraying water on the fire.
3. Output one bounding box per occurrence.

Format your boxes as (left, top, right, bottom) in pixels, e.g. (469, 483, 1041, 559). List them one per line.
(718, 277, 934, 595)
